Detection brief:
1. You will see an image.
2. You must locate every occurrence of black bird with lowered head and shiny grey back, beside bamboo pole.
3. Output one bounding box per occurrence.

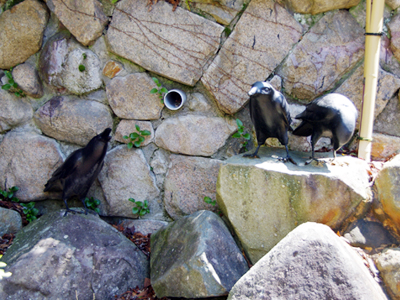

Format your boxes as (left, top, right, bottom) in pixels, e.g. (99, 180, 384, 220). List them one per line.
(293, 93, 358, 164)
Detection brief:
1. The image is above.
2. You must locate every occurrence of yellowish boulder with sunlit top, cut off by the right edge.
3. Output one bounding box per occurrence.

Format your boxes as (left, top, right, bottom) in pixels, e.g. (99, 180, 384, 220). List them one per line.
(374, 155, 400, 237)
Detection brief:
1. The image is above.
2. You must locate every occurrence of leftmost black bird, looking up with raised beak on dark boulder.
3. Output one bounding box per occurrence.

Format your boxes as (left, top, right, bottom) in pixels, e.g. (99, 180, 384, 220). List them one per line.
(44, 128, 111, 217)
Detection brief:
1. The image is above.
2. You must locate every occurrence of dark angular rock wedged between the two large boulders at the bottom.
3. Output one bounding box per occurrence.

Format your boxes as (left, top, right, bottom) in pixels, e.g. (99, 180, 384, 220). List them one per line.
(150, 211, 248, 298)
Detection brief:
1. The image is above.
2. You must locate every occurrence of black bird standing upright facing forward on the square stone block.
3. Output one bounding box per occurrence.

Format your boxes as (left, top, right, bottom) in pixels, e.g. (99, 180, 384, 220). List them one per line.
(243, 81, 296, 164)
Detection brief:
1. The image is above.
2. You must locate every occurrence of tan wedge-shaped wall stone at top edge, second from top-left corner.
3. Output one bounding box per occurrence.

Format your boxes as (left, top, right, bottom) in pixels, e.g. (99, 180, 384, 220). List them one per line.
(46, 0, 108, 46)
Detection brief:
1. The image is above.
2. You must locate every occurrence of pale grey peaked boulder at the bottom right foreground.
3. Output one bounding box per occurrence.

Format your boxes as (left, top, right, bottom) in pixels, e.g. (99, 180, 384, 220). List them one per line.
(228, 222, 388, 300)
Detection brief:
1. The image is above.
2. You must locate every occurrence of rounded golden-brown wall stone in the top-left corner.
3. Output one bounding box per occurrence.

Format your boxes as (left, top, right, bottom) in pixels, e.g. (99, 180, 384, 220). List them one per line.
(0, 0, 49, 69)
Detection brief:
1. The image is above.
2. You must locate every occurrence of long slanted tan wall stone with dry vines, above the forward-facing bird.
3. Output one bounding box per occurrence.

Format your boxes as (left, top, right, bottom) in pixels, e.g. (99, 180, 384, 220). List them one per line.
(201, 0, 303, 114)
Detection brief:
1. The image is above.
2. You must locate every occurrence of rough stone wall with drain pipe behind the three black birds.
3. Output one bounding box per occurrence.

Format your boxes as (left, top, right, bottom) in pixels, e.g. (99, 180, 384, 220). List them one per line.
(0, 0, 400, 220)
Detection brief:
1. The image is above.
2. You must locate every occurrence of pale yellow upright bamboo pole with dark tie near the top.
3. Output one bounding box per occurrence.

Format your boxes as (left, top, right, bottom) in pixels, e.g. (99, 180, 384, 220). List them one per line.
(358, 0, 385, 162)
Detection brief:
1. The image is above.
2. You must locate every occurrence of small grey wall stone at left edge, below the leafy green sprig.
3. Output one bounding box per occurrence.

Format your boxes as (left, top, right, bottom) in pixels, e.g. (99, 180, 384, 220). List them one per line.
(0, 89, 33, 132)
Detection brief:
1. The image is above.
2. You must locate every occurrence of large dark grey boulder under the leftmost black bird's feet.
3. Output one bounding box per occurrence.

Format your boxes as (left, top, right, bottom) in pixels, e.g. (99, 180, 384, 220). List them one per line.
(0, 210, 149, 300)
